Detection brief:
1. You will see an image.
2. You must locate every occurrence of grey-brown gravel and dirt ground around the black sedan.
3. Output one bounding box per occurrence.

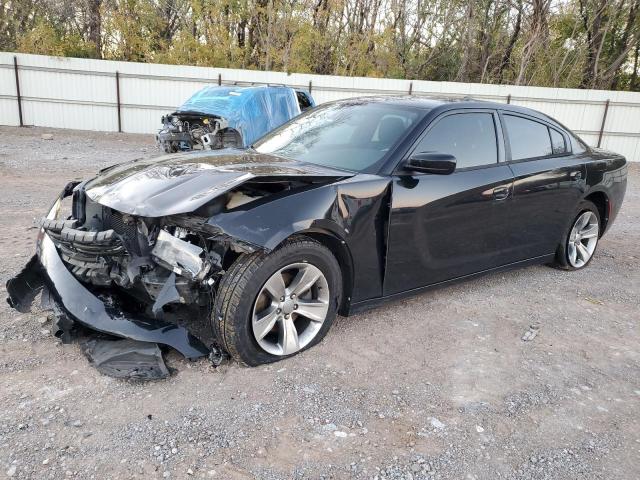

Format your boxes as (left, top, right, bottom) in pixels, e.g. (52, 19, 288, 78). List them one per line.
(0, 127, 640, 480)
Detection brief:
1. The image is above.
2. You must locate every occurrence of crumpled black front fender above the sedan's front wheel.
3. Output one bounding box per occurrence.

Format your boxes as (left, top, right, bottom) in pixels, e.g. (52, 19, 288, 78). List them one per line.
(207, 174, 391, 301)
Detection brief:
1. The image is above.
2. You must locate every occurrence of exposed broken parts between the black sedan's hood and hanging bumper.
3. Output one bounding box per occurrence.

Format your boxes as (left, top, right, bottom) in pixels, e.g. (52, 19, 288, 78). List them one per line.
(41, 199, 220, 316)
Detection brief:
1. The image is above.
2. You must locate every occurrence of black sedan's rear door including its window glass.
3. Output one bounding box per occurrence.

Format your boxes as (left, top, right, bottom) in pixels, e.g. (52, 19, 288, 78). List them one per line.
(500, 111, 586, 260)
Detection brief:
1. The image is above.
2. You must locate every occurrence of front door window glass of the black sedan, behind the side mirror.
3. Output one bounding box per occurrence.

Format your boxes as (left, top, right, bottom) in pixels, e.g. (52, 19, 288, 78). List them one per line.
(415, 112, 498, 169)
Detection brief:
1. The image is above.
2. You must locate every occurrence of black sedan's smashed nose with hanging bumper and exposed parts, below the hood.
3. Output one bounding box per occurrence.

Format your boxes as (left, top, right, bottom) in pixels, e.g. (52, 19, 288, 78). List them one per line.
(7, 184, 231, 366)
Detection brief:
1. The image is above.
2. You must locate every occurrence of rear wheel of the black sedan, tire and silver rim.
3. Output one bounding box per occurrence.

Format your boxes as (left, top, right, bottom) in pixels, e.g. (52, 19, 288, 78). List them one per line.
(556, 201, 600, 270)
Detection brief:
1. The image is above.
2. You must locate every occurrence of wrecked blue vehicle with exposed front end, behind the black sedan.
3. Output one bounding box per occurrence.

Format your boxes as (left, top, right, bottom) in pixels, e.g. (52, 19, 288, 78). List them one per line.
(156, 85, 315, 153)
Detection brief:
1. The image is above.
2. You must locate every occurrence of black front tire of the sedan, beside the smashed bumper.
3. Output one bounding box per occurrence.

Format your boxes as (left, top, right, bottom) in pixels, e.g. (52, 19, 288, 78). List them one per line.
(211, 236, 342, 366)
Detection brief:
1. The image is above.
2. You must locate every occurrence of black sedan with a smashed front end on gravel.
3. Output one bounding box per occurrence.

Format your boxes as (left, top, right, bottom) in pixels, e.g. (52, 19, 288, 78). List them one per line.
(7, 97, 627, 365)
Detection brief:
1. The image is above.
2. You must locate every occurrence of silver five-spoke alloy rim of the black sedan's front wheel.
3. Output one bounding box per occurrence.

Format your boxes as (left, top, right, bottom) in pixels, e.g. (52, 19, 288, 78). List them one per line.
(251, 263, 331, 356)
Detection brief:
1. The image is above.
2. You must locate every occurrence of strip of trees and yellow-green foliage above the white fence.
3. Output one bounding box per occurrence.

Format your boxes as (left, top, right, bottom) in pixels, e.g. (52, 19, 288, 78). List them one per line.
(5, 0, 640, 90)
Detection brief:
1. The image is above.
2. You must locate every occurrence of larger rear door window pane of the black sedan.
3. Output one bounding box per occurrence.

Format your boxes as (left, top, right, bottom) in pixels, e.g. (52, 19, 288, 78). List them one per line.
(503, 115, 564, 160)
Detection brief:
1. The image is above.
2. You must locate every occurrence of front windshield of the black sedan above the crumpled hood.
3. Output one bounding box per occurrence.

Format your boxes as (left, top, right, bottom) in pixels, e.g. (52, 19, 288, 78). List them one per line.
(253, 100, 427, 172)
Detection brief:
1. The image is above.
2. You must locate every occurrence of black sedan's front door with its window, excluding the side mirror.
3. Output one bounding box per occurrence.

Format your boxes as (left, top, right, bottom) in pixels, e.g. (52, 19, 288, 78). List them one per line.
(384, 109, 513, 295)
